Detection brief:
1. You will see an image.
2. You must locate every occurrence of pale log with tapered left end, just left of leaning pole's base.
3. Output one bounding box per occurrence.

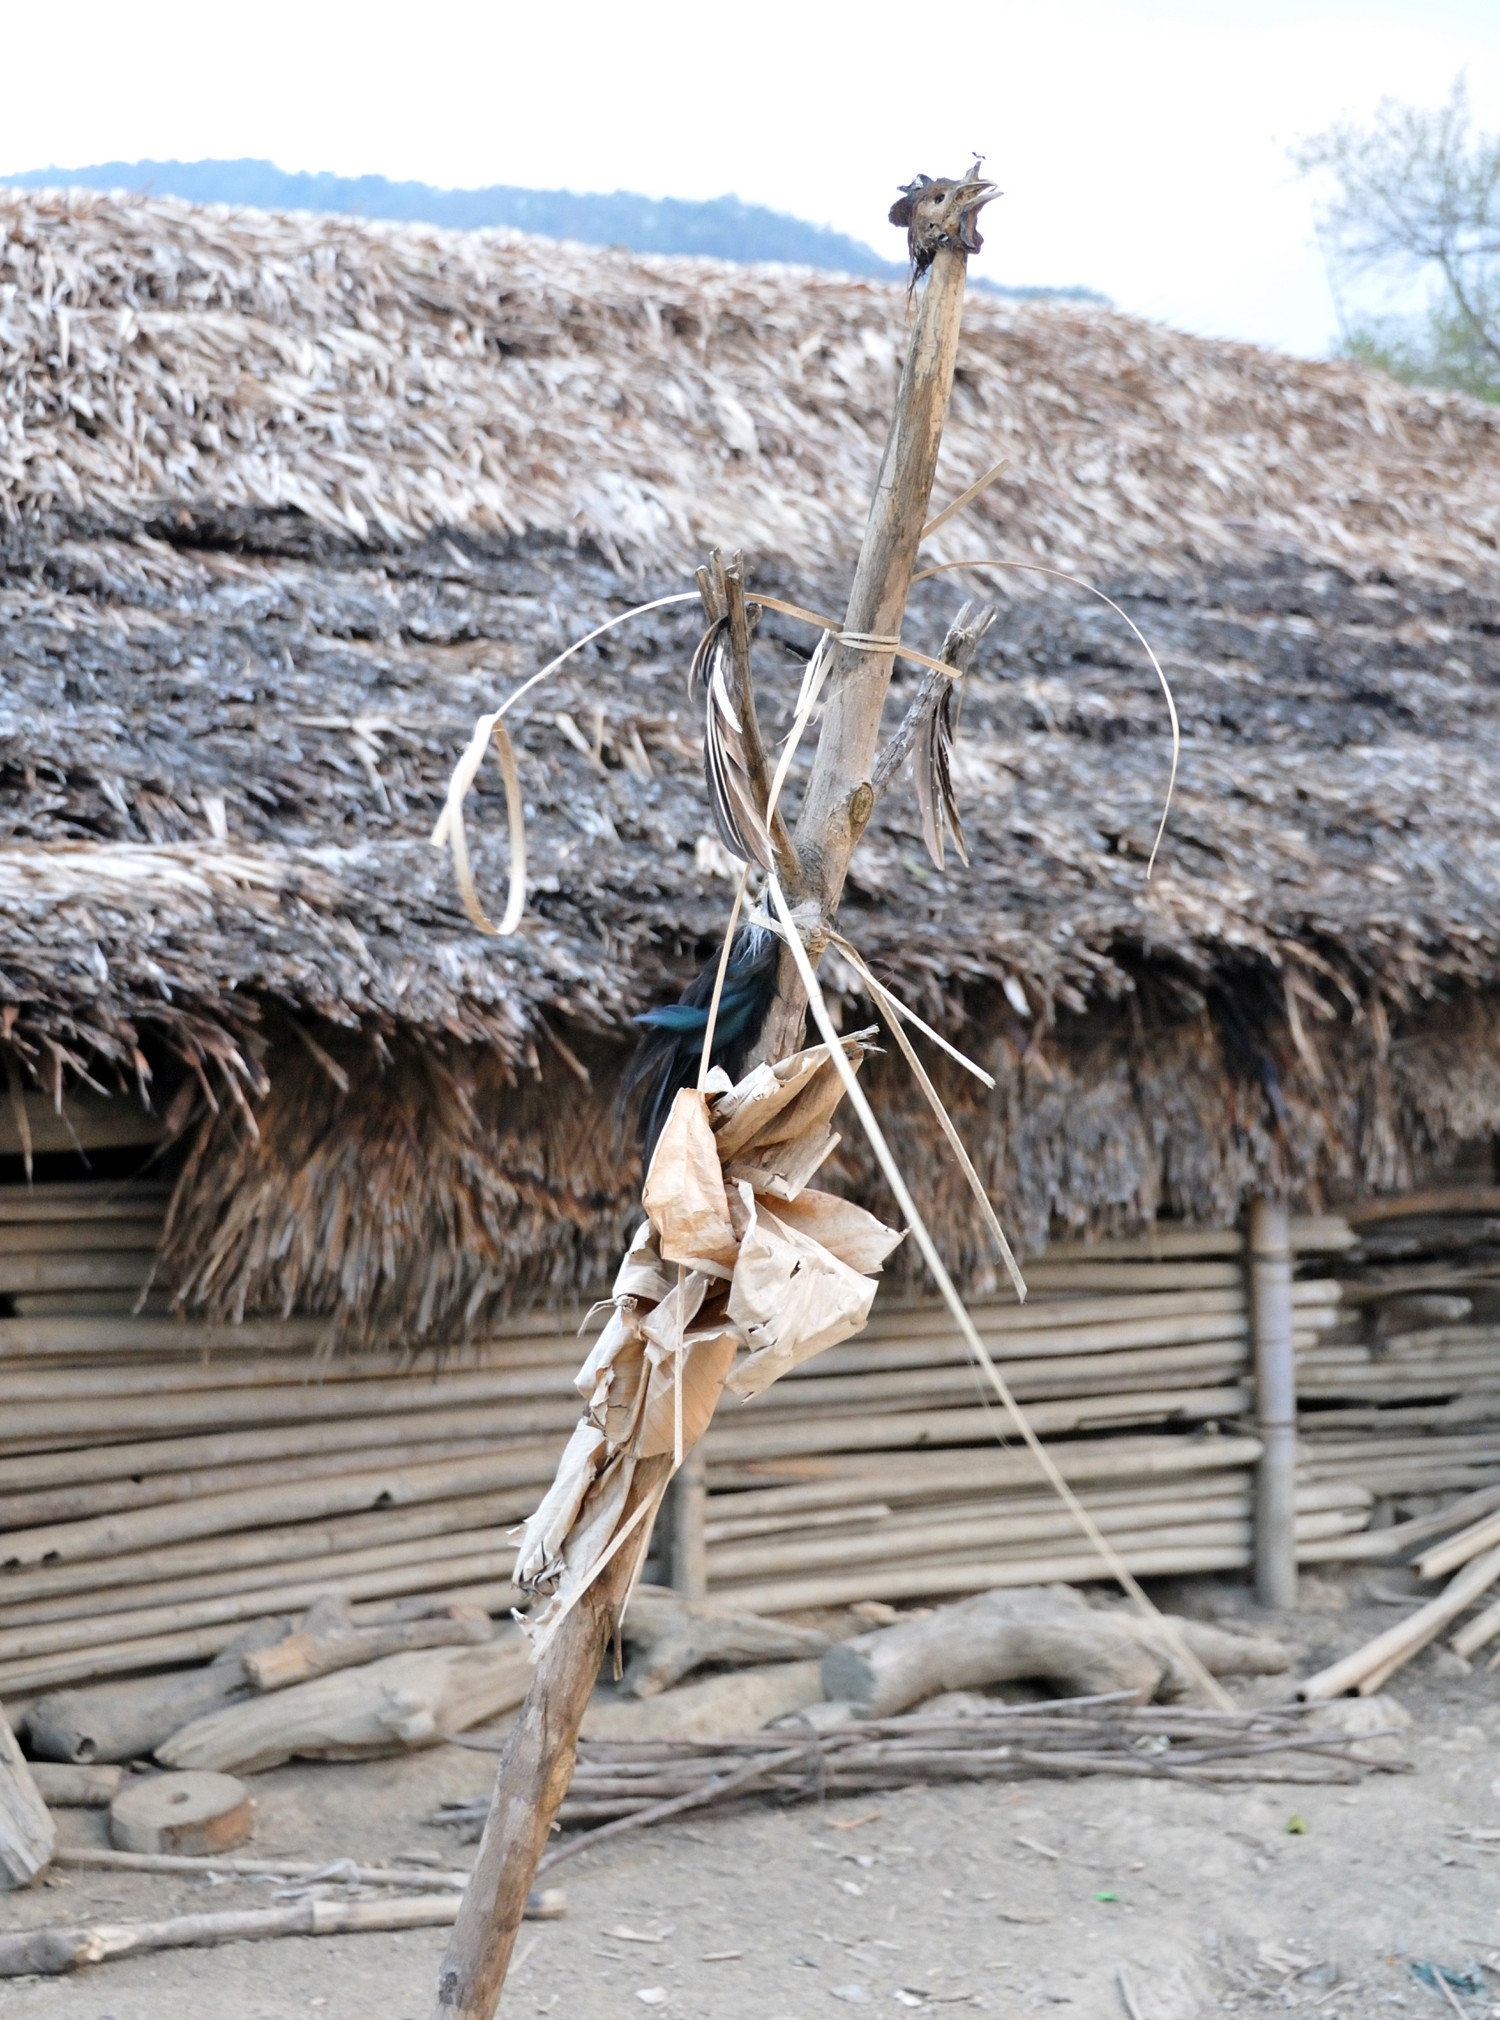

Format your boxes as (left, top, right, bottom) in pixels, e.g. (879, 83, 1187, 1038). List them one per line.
(155, 1626, 531, 1774)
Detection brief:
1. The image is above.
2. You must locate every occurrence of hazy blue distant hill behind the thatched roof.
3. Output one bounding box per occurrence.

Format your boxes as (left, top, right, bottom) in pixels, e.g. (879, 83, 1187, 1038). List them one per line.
(0, 162, 1106, 301)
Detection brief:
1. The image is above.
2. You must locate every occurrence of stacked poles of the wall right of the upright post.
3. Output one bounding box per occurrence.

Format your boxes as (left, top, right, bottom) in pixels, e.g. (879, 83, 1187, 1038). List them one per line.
(1296, 1186, 1500, 1557)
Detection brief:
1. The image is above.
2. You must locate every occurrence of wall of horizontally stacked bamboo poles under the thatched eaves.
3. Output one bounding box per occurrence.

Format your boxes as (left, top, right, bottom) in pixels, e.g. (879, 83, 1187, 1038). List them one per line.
(0, 1184, 1500, 1701)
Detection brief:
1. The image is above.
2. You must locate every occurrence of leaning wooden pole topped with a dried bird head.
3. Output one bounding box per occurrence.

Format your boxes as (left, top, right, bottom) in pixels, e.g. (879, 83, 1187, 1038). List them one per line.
(434, 174, 993, 2020)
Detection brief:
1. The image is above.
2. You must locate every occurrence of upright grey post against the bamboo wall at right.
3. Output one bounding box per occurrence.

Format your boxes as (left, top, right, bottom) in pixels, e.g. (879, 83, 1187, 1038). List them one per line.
(1250, 1198, 1296, 1606)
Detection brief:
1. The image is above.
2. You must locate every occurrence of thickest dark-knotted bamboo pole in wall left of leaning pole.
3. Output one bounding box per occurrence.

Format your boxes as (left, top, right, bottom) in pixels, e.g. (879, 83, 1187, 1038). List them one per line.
(0, 1438, 557, 1572)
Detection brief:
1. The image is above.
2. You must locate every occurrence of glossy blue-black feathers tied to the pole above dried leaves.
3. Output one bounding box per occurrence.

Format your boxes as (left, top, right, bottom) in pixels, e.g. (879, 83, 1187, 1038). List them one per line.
(626, 925, 781, 1168)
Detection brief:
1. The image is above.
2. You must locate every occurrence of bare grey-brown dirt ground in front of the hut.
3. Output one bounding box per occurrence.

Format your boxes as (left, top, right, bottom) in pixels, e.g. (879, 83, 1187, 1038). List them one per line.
(0, 1572, 1500, 2020)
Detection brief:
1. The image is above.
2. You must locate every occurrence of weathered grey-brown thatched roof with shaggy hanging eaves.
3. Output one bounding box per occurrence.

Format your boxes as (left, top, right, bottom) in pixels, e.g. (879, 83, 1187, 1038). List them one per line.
(0, 192, 1500, 1315)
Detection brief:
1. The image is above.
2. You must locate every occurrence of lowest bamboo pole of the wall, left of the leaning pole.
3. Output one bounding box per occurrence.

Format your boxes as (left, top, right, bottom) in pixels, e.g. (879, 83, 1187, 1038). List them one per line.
(0, 1529, 517, 1677)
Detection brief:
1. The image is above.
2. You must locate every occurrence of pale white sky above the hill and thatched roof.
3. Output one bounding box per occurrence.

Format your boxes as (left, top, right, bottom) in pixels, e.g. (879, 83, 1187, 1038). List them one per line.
(0, 0, 1500, 354)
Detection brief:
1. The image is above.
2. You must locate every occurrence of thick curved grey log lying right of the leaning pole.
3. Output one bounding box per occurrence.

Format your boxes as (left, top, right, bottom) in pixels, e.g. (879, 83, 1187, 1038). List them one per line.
(824, 1588, 1290, 1719)
